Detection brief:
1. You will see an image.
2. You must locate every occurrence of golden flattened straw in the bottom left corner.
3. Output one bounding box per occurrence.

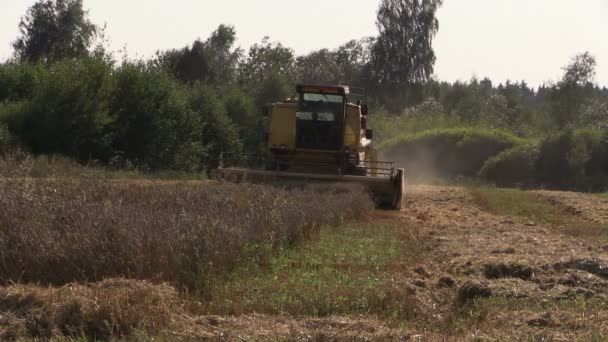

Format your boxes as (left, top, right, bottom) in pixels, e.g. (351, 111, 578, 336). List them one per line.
(0, 279, 187, 340)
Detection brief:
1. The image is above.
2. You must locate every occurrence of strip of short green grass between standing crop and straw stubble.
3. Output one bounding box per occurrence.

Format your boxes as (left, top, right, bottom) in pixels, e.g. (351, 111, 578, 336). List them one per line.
(204, 225, 424, 319)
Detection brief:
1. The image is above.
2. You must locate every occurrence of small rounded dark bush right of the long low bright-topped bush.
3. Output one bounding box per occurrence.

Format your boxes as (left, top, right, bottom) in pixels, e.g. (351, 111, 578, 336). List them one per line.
(479, 144, 539, 187)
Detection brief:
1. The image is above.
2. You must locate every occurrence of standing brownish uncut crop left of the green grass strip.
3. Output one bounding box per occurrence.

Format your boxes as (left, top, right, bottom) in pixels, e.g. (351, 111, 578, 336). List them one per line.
(0, 180, 372, 292)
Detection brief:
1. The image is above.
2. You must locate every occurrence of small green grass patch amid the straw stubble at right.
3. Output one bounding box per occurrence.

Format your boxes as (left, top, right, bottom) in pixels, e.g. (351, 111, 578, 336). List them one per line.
(471, 187, 574, 224)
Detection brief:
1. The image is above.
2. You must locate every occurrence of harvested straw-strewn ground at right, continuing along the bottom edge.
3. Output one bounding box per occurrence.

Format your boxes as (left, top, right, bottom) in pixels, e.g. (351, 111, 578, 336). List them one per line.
(188, 186, 608, 341)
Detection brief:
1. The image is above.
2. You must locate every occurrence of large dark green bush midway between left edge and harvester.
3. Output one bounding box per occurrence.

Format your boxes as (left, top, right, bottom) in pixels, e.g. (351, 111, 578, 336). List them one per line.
(108, 64, 205, 170)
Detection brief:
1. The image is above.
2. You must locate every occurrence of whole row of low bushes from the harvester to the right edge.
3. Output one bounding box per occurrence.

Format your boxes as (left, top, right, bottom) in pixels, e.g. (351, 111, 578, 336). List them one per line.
(380, 124, 608, 191)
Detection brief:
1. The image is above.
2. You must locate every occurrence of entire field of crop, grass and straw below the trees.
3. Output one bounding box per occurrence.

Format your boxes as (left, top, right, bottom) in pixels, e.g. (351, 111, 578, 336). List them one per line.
(0, 181, 608, 341)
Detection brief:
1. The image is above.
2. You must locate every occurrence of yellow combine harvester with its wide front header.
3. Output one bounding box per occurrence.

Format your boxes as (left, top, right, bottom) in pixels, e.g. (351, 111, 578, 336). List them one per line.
(217, 85, 405, 209)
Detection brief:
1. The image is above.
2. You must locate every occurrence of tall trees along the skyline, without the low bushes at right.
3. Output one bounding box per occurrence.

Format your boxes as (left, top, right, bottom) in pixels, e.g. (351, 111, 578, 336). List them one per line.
(0, 0, 608, 171)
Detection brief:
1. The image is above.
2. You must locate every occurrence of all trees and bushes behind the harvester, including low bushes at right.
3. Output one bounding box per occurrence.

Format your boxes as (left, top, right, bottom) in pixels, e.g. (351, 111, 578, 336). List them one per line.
(0, 0, 608, 190)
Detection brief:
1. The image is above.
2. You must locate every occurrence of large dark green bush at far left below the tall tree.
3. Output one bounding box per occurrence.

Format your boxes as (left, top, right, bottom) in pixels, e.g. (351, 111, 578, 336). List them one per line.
(7, 58, 111, 160)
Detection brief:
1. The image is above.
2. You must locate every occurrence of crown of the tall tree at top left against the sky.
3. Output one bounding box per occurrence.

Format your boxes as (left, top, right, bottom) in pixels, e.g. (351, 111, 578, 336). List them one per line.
(13, 0, 98, 62)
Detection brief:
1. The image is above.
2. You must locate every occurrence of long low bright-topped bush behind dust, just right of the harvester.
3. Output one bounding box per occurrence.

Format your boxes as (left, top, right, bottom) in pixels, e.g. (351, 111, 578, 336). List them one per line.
(381, 128, 524, 177)
